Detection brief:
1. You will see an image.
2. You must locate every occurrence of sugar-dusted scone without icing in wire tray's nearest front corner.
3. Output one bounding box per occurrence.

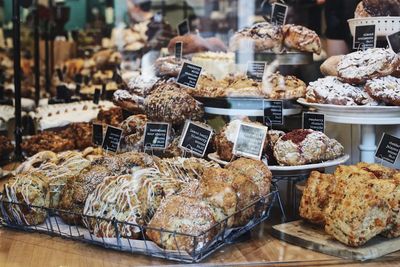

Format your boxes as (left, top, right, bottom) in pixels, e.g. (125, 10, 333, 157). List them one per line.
(146, 196, 217, 253)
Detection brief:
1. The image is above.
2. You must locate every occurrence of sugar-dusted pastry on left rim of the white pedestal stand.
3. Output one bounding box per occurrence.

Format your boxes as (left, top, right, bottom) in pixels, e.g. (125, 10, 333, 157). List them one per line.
(306, 76, 376, 106)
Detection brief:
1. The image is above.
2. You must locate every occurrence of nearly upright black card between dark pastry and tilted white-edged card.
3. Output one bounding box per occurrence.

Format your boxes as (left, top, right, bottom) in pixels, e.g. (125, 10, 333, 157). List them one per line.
(144, 122, 170, 149)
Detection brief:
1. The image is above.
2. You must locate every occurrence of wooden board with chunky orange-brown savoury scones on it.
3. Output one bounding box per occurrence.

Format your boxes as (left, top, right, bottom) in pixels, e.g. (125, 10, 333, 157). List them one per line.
(273, 162, 400, 261)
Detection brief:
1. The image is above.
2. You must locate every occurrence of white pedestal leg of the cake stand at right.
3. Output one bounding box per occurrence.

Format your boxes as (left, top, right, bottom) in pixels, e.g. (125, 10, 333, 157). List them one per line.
(359, 125, 376, 163)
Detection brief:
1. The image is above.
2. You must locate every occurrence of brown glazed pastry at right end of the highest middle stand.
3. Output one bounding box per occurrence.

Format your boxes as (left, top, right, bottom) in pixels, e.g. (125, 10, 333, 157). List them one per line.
(282, 24, 322, 55)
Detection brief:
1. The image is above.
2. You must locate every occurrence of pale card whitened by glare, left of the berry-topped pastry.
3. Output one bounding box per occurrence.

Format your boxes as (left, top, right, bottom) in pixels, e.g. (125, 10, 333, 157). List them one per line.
(233, 123, 268, 160)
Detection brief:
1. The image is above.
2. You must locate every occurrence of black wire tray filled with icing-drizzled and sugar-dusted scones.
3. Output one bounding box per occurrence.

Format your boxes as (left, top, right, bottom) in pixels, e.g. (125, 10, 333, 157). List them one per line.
(0, 151, 278, 262)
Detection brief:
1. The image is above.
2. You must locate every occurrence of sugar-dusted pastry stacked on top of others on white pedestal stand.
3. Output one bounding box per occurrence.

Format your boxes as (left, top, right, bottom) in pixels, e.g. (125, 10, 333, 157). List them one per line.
(337, 48, 400, 84)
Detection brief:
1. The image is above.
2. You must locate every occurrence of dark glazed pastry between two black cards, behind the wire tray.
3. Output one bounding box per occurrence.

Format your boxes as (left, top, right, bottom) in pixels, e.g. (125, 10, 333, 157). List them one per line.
(119, 115, 147, 150)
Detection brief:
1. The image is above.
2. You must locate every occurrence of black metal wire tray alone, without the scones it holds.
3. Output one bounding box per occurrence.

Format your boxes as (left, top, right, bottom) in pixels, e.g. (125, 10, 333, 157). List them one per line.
(0, 185, 281, 263)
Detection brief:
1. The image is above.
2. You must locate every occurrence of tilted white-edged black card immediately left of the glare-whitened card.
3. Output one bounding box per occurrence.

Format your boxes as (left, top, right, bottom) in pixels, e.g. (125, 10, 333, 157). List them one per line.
(179, 121, 213, 157)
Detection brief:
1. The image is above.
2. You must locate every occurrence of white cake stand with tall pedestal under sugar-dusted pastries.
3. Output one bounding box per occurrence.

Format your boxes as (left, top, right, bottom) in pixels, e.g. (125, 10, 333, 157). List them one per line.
(297, 99, 400, 163)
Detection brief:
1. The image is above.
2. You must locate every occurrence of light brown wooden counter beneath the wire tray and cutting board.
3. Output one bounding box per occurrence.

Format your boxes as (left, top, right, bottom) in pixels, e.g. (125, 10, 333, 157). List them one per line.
(0, 224, 400, 267)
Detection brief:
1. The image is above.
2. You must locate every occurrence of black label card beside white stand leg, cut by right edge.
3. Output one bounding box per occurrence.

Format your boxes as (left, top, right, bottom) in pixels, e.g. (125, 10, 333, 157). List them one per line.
(375, 133, 400, 164)
